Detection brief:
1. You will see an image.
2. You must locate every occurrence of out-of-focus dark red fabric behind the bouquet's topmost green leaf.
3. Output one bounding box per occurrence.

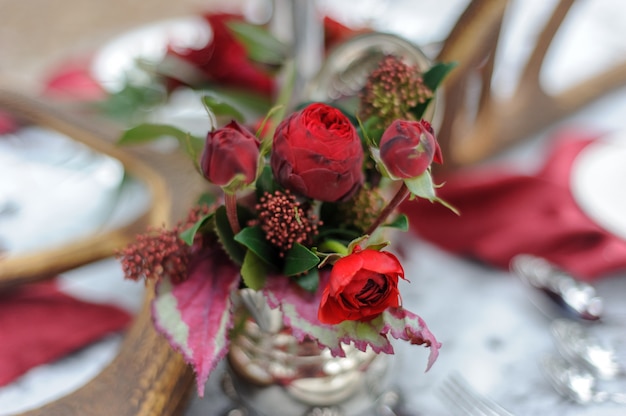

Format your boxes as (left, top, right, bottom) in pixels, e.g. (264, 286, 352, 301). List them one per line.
(168, 13, 274, 96)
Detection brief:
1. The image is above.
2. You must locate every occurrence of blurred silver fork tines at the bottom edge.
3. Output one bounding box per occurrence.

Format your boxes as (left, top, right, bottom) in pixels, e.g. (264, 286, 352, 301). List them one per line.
(439, 373, 513, 416)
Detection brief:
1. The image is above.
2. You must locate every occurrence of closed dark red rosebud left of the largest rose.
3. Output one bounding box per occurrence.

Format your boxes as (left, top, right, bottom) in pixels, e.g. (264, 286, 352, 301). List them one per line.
(200, 120, 259, 186)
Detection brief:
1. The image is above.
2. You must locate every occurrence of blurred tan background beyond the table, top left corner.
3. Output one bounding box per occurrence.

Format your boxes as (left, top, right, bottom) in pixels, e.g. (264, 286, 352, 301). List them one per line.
(0, 0, 224, 91)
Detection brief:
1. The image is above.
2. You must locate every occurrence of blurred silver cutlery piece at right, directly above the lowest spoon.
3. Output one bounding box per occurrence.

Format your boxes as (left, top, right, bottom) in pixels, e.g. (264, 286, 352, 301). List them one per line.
(550, 319, 624, 379)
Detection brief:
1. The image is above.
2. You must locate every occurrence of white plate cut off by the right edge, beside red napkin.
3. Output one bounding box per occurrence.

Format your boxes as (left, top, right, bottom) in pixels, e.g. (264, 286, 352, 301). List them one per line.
(570, 131, 626, 239)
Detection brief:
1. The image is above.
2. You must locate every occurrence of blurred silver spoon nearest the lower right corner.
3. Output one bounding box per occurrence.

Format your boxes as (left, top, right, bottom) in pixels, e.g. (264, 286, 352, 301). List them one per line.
(542, 355, 626, 404)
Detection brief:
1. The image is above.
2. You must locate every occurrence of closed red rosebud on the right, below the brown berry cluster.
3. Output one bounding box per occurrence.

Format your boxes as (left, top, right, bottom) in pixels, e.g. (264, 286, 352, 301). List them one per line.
(379, 120, 443, 179)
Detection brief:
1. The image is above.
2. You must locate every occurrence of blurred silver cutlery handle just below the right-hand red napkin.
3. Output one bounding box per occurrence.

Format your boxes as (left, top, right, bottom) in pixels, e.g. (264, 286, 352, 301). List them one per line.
(511, 254, 604, 321)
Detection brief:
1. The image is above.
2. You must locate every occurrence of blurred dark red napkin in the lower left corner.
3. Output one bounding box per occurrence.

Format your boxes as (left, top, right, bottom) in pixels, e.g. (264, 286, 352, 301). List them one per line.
(0, 280, 130, 386)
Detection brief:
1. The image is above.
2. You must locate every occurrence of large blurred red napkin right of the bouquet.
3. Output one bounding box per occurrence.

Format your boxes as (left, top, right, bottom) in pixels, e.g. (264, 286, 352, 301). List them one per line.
(402, 131, 626, 280)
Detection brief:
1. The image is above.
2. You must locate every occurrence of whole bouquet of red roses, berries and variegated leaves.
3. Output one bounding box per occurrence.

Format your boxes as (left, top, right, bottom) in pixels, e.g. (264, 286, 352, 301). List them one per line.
(114, 11, 452, 395)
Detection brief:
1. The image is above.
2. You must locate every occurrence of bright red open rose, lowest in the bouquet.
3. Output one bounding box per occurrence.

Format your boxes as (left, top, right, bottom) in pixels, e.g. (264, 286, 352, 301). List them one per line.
(317, 248, 404, 324)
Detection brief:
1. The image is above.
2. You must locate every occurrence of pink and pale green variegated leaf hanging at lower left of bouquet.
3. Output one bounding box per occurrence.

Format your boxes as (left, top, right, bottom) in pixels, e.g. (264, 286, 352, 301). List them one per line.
(152, 249, 240, 397)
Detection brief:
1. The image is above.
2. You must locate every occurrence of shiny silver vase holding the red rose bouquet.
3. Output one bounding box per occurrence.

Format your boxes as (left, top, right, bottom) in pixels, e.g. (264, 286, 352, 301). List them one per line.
(223, 289, 389, 416)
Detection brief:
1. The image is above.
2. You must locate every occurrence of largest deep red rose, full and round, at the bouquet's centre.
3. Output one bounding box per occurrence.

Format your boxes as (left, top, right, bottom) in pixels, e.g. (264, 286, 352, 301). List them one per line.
(270, 103, 363, 202)
